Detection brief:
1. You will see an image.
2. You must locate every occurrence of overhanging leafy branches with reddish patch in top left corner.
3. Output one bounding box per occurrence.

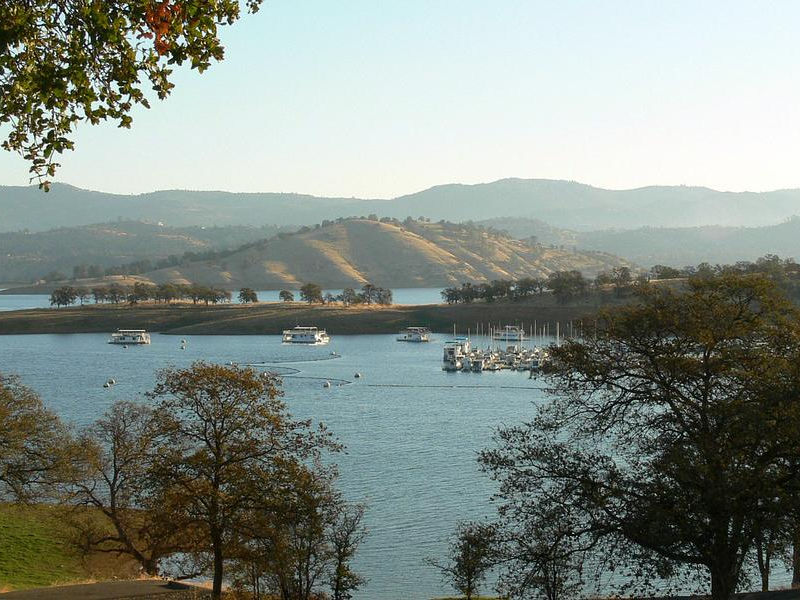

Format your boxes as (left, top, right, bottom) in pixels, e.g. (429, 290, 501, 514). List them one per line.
(0, 0, 268, 188)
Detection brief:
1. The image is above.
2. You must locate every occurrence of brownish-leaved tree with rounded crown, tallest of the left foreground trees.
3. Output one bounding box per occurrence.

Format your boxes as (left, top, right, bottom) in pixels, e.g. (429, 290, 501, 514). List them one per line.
(150, 362, 338, 598)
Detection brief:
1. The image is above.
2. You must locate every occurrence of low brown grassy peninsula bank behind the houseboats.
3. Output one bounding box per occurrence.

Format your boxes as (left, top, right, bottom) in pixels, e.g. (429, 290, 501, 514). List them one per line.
(0, 296, 602, 336)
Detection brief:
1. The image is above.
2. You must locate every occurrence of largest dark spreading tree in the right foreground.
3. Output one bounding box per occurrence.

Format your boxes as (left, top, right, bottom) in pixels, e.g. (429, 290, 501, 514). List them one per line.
(481, 275, 800, 600)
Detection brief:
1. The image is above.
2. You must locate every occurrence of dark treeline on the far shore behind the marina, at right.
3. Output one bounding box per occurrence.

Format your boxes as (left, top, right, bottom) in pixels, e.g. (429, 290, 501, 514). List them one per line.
(442, 254, 800, 304)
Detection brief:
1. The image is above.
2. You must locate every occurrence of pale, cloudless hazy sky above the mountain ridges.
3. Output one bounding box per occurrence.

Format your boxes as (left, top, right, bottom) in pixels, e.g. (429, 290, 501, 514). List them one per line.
(0, 0, 800, 197)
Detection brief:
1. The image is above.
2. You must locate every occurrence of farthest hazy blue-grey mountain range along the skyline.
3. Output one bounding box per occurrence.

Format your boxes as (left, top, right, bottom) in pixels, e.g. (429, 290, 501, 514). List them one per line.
(0, 179, 800, 231)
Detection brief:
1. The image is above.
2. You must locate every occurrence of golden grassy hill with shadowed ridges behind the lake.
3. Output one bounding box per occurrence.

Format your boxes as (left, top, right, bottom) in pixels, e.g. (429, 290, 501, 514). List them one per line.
(48, 219, 629, 289)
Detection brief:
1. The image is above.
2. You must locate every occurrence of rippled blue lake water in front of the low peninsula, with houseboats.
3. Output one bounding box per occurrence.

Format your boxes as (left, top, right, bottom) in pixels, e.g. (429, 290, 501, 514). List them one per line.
(0, 334, 543, 600)
